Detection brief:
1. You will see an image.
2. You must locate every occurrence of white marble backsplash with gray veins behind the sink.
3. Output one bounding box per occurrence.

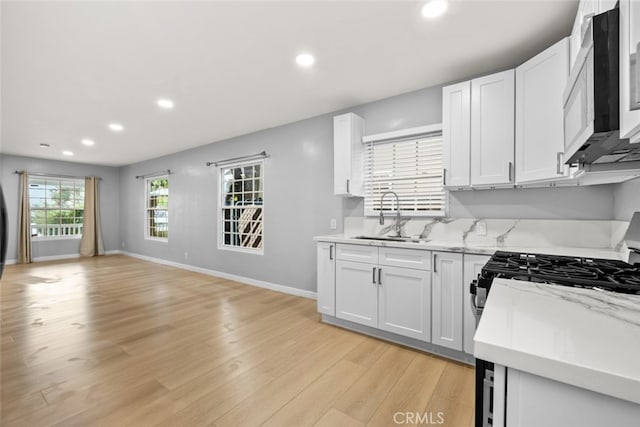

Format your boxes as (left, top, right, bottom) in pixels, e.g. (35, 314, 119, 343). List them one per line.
(344, 217, 629, 250)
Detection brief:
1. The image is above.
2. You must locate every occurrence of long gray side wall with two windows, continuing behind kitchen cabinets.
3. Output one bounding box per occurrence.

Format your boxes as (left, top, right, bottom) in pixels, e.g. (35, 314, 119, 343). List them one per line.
(120, 83, 614, 291)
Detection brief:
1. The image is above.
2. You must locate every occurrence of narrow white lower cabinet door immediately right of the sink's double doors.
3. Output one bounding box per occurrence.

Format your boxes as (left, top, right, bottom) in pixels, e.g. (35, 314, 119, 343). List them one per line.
(431, 252, 463, 350)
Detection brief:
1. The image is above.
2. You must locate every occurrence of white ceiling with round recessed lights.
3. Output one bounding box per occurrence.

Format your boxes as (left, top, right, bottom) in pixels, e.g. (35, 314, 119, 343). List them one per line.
(1, 0, 577, 166)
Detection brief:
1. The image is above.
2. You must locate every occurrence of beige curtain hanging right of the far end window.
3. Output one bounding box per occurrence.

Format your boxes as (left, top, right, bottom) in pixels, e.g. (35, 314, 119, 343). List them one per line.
(80, 176, 104, 256)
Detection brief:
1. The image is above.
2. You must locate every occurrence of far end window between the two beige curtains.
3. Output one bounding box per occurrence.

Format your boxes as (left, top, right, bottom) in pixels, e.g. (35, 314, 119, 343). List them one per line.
(29, 176, 84, 240)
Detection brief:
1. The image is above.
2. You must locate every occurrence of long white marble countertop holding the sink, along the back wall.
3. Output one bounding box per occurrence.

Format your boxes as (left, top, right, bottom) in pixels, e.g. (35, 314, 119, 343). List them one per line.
(313, 234, 628, 261)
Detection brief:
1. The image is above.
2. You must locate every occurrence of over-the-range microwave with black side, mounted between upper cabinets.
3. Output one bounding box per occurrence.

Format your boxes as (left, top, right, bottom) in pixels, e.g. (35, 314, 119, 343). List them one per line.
(564, 8, 640, 164)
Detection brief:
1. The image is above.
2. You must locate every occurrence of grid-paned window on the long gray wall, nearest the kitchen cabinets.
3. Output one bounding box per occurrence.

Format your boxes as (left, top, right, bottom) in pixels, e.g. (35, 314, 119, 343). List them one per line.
(220, 161, 264, 253)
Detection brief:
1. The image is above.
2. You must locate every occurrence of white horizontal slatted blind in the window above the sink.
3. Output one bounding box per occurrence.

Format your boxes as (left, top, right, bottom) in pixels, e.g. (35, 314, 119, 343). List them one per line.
(364, 134, 446, 216)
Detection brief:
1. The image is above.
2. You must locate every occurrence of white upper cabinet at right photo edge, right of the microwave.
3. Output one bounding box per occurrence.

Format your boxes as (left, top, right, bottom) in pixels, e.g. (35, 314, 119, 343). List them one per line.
(620, 0, 640, 142)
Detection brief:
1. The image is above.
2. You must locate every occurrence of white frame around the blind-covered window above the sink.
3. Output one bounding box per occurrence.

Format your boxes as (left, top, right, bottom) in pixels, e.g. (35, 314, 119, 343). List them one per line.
(363, 128, 449, 218)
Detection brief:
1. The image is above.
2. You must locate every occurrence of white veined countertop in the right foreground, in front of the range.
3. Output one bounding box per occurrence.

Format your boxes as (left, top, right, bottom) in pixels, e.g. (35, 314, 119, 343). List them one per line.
(474, 279, 640, 403)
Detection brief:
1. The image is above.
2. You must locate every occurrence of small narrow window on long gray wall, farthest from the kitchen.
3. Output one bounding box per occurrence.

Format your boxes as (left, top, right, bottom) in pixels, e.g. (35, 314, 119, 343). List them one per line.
(145, 176, 169, 241)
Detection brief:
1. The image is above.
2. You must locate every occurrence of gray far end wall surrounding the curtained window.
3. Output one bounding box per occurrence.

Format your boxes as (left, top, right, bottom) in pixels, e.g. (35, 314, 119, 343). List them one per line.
(0, 154, 120, 260)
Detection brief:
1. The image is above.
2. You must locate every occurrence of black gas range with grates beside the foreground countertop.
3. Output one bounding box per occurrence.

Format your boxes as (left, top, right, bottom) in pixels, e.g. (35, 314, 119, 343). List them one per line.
(470, 251, 640, 427)
